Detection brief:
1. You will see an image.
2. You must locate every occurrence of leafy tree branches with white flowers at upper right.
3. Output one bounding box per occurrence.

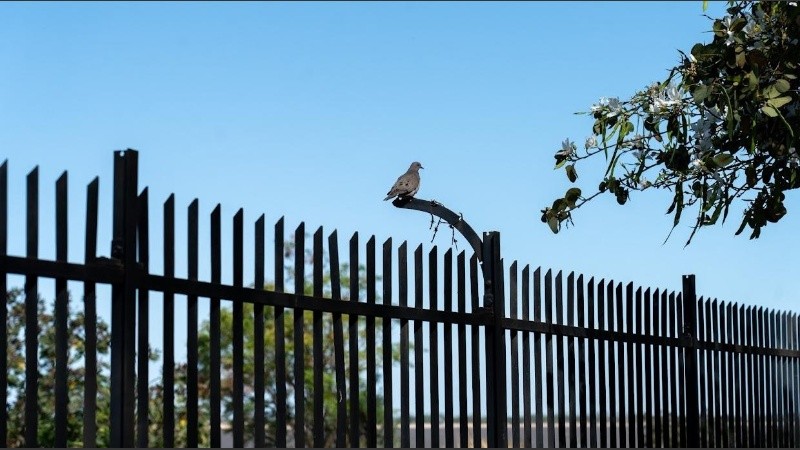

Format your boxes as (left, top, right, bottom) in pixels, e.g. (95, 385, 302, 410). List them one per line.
(541, 0, 800, 244)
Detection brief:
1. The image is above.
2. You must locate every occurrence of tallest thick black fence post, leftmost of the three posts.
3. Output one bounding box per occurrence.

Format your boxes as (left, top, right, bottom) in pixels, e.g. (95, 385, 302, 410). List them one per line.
(111, 150, 138, 448)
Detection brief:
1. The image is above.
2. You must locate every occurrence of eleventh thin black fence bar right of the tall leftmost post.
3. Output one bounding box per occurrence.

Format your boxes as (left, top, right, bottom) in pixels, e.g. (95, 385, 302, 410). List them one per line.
(348, 232, 361, 447)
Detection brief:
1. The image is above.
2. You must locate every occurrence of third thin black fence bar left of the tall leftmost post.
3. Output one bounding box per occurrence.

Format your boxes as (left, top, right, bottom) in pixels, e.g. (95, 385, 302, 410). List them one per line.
(25, 166, 39, 447)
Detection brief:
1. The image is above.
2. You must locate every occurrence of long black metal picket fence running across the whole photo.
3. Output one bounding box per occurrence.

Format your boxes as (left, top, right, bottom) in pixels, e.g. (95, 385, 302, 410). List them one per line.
(0, 150, 800, 447)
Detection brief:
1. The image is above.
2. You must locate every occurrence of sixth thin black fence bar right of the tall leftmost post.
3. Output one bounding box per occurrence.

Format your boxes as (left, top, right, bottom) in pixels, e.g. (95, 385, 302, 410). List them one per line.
(253, 214, 266, 448)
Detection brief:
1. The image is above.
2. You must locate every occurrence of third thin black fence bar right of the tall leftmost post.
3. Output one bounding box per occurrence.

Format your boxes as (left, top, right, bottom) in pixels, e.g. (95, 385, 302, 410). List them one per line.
(186, 199, 199, 447)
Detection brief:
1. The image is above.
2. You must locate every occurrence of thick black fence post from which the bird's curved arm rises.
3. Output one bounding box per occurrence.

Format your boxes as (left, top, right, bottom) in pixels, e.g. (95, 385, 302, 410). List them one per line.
(482, 231, 508, 448)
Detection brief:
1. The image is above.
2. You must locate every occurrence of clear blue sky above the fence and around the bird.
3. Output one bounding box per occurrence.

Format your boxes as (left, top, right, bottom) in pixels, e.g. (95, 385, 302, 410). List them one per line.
(0, 1, 800, 418)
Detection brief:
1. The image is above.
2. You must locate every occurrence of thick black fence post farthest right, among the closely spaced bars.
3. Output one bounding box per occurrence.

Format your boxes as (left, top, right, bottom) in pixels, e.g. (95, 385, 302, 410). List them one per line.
(683, 275, 700, 448)
